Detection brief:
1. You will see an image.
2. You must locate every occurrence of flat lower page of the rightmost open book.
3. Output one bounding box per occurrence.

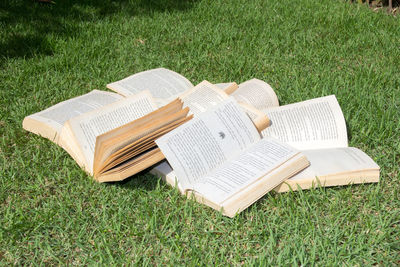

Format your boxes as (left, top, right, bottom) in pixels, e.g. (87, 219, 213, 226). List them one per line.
(289, 147, 379, 181)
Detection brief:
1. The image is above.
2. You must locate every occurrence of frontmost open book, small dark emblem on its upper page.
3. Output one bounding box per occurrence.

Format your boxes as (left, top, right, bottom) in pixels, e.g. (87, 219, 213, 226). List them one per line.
(156, 98, 309, 217)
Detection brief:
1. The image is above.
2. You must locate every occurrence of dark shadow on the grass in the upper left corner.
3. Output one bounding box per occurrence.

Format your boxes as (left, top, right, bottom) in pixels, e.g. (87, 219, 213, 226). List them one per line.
(0, 0, 197, 63)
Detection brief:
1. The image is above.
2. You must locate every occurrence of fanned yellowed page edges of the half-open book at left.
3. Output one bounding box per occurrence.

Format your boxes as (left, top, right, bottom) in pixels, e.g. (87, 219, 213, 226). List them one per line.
(94, 100, 191, 182)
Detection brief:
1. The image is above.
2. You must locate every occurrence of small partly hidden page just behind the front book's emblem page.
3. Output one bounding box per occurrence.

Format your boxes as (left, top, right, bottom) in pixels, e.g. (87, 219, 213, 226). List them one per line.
(179, 81, 228, 116)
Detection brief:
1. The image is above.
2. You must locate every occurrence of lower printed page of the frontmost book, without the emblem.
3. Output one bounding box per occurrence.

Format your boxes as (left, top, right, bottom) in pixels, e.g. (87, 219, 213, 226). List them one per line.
(193, 138, 298, 204)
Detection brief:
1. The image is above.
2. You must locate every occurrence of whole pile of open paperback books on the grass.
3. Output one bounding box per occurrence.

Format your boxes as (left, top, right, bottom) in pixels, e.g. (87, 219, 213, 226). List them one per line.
(23, 68, 379, 203)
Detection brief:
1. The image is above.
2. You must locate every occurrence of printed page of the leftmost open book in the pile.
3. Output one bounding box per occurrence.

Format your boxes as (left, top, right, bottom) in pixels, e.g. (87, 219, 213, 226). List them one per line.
(25, 90, 123, 140)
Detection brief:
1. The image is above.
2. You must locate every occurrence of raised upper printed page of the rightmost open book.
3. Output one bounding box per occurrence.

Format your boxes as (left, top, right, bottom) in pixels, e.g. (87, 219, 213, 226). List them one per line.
(262, 95, 348, 150)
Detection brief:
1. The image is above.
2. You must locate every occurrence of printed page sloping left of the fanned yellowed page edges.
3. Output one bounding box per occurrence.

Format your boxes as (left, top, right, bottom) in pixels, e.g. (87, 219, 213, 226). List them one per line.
(68, 91, 156, 173)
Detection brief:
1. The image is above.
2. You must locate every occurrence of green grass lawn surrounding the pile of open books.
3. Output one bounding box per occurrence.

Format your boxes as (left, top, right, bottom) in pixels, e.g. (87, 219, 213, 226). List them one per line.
(0, 0, 400, 266)
